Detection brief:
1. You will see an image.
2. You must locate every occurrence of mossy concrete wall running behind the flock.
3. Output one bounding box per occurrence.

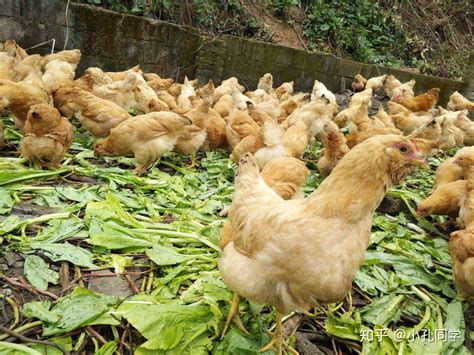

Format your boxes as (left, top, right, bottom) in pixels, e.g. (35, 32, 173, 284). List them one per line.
(0, 0, 472, 103)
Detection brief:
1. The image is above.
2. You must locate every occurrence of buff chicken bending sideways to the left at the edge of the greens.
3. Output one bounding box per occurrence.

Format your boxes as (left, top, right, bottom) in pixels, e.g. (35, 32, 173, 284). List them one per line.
(94, 112, 191, 175)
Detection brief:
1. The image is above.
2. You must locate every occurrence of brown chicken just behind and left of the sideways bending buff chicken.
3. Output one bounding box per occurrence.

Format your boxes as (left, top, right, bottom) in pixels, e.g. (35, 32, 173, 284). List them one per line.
(53, 86, 132, 137)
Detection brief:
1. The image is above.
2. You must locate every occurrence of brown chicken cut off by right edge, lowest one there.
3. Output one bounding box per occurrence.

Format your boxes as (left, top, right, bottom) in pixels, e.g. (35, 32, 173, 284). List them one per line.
(449, 228, 474, 298)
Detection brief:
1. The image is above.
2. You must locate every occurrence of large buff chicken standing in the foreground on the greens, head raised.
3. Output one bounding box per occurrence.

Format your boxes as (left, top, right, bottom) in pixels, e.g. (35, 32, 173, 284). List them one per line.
(219, 135, 425, 354)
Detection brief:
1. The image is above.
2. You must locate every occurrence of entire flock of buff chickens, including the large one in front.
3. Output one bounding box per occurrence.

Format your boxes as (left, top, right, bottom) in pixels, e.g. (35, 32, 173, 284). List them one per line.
(0, 41, 474, 351)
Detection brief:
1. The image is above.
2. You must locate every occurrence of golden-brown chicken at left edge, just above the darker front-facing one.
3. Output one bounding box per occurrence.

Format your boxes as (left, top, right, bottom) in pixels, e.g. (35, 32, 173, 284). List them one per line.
(0, 80, 49, 130)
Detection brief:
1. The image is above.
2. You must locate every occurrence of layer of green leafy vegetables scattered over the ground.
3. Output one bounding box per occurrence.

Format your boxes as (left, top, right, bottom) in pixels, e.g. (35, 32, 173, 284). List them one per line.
(0, 118, 472, 354)
